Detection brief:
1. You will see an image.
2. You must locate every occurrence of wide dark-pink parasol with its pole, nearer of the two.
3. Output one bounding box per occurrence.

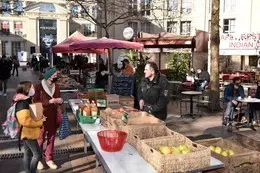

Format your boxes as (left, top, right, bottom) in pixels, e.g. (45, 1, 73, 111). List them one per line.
(70, 37, 144, 92)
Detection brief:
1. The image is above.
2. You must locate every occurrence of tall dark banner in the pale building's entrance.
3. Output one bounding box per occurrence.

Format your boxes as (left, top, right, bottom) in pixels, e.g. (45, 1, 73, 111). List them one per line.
(39, 19, 57, 57)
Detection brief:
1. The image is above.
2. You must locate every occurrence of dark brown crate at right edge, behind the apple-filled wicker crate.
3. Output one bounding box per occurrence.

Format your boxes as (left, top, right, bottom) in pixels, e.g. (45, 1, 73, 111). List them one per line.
(233, 130, 260, 152)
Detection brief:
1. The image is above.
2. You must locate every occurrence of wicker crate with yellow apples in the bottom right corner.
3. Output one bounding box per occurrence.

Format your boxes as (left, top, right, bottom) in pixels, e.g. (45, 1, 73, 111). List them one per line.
(196, 138, 260, 173)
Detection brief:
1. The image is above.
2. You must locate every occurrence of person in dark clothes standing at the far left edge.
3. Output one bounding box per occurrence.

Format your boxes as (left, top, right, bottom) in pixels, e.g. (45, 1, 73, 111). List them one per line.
(0, 55, 12, 96)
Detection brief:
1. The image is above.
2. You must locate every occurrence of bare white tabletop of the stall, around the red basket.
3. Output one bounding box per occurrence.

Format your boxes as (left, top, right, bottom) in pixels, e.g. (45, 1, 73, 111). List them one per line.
(69, 99, 224, 173)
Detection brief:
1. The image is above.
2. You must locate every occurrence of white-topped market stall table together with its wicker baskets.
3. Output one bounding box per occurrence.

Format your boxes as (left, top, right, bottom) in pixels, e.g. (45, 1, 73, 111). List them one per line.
(69, 99, 224, 173)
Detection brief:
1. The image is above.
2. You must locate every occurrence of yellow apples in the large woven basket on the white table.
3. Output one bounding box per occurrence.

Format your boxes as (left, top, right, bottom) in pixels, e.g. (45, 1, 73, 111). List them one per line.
(158, 144, 191, 155)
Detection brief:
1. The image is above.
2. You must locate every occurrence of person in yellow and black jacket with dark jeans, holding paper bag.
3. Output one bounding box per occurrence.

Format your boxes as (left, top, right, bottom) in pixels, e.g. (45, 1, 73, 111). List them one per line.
(14, 81, 45, 173)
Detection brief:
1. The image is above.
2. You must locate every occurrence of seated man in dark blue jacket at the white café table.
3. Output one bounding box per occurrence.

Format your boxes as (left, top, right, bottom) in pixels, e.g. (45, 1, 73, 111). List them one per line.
(223, 77, 245, 125)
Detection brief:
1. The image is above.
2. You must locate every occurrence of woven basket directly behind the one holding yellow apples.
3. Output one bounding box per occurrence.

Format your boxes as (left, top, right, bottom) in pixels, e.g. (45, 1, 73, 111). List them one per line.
(122, 124, 175, 153)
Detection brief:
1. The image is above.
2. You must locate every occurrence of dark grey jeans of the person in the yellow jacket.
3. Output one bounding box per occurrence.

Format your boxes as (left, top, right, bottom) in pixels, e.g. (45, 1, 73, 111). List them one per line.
(23, 139, 42, 173)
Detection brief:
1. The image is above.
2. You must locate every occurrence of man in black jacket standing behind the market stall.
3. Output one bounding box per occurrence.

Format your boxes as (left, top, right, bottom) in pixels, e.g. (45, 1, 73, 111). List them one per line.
(138, 62, 169, 121)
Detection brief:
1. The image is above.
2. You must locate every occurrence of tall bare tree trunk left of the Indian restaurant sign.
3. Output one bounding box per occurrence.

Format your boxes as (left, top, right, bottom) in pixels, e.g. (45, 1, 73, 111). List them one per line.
(210, 0, 220, 110)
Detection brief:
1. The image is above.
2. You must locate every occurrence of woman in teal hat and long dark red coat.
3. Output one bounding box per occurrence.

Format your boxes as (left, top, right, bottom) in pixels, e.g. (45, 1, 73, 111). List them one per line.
(34, 68, 63, 170)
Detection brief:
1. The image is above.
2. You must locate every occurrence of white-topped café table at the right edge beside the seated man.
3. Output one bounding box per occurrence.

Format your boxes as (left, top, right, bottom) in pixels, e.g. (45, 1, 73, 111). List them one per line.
(236, 97, 260, 131)
